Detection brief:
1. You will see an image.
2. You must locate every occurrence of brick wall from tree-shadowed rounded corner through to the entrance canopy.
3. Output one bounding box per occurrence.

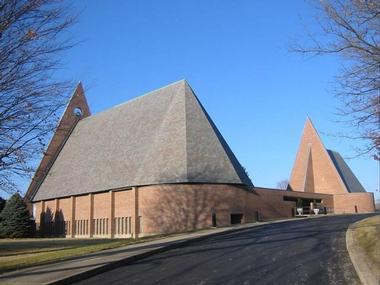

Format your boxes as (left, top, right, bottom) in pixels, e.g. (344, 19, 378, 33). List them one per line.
(139, 184, 333, 234)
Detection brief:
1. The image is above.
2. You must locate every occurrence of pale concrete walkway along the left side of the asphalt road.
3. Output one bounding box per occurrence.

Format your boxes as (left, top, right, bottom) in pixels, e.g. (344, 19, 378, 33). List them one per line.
(0, 216, 324, 285)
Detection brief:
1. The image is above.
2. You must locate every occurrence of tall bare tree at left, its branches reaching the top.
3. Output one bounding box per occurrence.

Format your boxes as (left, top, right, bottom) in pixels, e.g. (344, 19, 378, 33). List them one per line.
(0, 0, 74, 193)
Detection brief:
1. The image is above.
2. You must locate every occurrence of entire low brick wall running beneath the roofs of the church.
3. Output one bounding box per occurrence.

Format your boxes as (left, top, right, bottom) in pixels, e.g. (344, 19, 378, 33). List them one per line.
(34, 184, 374, 238)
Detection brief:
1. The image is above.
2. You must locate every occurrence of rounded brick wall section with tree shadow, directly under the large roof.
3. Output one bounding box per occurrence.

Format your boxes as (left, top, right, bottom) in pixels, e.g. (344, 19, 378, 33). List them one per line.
(139, 184, 255, 234)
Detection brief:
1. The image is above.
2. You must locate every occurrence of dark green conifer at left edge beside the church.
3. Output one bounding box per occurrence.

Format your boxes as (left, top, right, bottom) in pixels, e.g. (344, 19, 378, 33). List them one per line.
(0, 193, 32, 238)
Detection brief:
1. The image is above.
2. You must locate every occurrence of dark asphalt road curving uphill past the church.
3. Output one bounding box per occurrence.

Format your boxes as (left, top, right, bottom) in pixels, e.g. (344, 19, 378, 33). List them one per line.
(72, 215, 368, 285)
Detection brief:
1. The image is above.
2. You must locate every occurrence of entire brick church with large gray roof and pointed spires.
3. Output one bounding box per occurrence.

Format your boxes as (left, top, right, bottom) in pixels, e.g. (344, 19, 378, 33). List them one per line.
(25, 80, 374, 237)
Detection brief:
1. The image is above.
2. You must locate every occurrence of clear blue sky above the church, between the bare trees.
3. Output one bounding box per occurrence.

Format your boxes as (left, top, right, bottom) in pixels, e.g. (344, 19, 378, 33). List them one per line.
(16, 0, 379, 196)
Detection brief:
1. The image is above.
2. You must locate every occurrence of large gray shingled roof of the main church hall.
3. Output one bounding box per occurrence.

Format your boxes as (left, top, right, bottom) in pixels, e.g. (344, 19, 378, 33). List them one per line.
(33, 80, 252, 201)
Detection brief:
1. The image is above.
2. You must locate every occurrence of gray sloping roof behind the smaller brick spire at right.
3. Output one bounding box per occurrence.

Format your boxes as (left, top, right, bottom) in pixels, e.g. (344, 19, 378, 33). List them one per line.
(327, 149, 366, 193)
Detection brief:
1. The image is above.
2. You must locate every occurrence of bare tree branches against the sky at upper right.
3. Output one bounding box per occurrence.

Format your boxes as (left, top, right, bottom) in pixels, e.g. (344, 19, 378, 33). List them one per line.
(291, 0, 380, 160)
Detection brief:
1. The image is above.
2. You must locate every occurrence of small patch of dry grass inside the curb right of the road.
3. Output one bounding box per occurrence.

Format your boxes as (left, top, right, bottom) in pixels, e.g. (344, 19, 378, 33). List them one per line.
(352, 215, 380, 272)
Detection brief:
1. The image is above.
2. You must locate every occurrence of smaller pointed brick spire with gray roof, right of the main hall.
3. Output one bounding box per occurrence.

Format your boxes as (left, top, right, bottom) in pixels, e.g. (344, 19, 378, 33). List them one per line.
(289, 118, 365, 194)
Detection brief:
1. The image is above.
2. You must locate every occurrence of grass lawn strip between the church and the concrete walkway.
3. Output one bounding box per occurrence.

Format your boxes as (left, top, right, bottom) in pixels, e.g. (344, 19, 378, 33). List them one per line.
(0, 236, 162, 273)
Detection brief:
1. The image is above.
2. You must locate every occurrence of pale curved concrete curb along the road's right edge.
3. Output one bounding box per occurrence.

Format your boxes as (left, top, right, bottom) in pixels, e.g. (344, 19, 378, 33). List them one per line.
(346, 216, 379, 285)
